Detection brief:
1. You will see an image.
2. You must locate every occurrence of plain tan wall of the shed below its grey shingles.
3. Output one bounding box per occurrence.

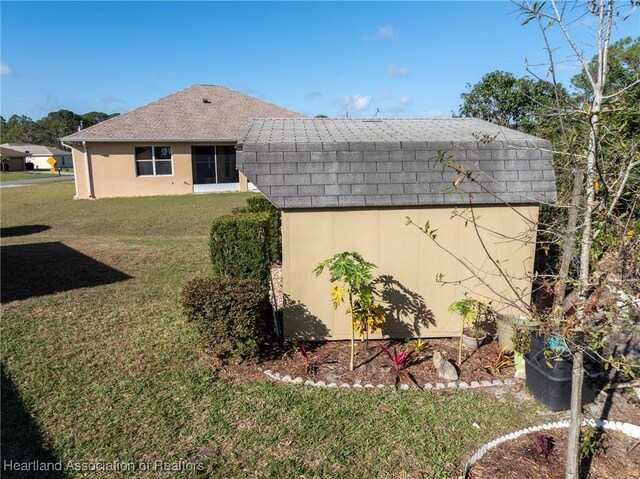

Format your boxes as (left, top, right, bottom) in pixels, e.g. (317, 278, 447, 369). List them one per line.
(282, 206, 538, 339)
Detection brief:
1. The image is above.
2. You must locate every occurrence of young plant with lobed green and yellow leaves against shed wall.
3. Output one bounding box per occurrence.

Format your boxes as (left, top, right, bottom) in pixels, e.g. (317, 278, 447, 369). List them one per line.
(313, 251, 384, 371)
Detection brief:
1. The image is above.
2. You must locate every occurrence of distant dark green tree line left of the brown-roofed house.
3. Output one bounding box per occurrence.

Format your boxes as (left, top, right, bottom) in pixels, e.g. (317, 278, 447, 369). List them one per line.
(0, 110, 120, 148)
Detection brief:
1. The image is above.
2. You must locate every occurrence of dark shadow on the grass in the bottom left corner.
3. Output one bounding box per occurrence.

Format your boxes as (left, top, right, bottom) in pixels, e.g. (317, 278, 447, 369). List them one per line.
(0, 364, 65, 479)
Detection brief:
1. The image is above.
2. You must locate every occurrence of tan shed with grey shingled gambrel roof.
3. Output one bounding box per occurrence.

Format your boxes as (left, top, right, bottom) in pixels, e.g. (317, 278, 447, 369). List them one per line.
(237, 118, 556, 339)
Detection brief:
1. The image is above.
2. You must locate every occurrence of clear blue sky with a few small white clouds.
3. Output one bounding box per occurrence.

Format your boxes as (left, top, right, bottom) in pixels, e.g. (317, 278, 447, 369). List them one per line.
(0, 0, 640, 119)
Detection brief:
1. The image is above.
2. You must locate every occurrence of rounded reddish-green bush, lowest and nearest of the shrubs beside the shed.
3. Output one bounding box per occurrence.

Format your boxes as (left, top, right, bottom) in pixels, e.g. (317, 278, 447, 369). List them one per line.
(182, 277, 271, 358)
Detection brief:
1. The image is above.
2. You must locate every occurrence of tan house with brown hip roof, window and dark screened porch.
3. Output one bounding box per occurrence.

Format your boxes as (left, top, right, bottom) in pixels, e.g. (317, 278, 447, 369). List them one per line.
(61, 85, 304, 198)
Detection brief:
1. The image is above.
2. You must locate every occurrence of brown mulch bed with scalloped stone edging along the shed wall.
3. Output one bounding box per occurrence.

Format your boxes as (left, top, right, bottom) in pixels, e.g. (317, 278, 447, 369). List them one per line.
(212, 339, 514, 386)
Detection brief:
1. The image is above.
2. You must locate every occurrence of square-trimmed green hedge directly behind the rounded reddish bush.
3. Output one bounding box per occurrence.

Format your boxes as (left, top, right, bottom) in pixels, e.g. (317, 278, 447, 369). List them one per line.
(209, 213, 271, 287)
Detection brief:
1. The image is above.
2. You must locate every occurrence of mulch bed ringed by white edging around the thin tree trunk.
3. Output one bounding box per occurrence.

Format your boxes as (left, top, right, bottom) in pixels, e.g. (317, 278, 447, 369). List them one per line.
(468, 429, 640, 479)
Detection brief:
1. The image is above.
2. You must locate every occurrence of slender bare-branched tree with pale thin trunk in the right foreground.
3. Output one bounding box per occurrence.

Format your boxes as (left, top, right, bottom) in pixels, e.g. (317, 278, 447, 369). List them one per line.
(514, 0, 639, 479)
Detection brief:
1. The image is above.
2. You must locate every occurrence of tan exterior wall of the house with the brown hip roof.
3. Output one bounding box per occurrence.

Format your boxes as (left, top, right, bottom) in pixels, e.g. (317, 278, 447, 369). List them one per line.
(73, 141, 235, 198)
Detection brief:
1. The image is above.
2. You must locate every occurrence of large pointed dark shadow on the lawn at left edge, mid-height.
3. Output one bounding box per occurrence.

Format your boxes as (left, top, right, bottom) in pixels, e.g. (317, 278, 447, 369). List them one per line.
(0, 242, 131, 303)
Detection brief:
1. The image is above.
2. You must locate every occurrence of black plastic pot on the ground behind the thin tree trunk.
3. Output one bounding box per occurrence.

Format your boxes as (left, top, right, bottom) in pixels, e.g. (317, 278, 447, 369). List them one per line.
(524, 353, 606, 411)
